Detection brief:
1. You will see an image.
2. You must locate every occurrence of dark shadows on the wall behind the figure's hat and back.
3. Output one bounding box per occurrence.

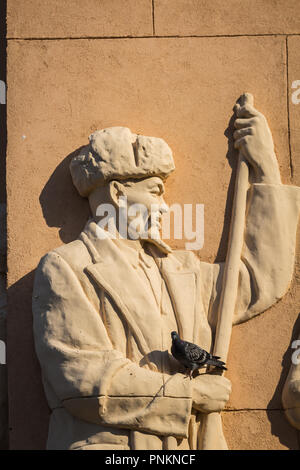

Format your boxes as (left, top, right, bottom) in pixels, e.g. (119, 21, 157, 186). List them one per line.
(7, 149, 90, 450)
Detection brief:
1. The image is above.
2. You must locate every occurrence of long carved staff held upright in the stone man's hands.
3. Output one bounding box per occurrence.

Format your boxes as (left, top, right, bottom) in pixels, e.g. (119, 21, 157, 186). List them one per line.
(201, 93, 253, 450)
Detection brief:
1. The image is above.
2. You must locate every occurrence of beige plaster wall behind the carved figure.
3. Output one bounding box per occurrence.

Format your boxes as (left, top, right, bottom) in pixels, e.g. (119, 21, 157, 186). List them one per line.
(7, 0, 300, 449)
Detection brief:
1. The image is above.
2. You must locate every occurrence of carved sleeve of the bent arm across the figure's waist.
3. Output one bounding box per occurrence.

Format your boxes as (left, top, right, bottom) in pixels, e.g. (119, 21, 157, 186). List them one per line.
(33, 251, 192, 437)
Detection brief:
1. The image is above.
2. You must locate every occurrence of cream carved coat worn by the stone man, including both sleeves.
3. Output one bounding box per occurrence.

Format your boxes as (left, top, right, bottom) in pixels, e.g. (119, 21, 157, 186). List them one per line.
(33, 184, 300, 449)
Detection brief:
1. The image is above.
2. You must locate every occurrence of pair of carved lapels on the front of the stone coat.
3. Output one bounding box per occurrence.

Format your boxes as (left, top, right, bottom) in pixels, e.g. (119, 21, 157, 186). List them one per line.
(80, 220, 200, 356)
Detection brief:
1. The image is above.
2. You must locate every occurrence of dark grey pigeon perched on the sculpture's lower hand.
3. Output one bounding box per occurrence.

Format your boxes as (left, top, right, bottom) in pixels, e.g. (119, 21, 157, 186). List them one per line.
(171, 331, 227, 379)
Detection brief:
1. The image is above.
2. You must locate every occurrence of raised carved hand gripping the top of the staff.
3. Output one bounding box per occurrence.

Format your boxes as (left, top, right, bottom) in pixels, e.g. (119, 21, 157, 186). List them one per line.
(233, 98, 281, 184)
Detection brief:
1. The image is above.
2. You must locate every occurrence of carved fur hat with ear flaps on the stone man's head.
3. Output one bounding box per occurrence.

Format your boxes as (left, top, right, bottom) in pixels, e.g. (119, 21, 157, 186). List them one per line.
(70, 127, 175, 197)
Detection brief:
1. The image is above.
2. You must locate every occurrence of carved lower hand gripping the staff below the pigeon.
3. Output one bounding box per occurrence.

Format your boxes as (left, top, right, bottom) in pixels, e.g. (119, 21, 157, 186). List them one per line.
(192, 374, 231, 413)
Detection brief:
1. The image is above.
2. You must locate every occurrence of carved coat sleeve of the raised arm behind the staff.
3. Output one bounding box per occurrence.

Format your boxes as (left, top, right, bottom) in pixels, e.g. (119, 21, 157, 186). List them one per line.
(200, 184, 300, 328)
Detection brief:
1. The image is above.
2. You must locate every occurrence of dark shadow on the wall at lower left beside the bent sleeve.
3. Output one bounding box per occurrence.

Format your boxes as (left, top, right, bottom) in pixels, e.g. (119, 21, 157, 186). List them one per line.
(7, 271, 49, 450)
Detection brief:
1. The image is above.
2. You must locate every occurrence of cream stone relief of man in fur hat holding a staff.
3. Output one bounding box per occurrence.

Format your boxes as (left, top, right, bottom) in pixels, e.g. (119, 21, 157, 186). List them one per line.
(33, 96, 300, 450)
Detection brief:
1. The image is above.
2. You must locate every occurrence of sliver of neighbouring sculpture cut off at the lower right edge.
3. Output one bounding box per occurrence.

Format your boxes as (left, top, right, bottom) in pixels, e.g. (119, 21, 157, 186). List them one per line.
(282, 324, 300, 430)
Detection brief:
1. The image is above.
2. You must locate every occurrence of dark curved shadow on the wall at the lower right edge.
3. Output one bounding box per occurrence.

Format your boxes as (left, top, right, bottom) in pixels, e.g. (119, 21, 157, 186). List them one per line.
(267, 314, 300, 450)
